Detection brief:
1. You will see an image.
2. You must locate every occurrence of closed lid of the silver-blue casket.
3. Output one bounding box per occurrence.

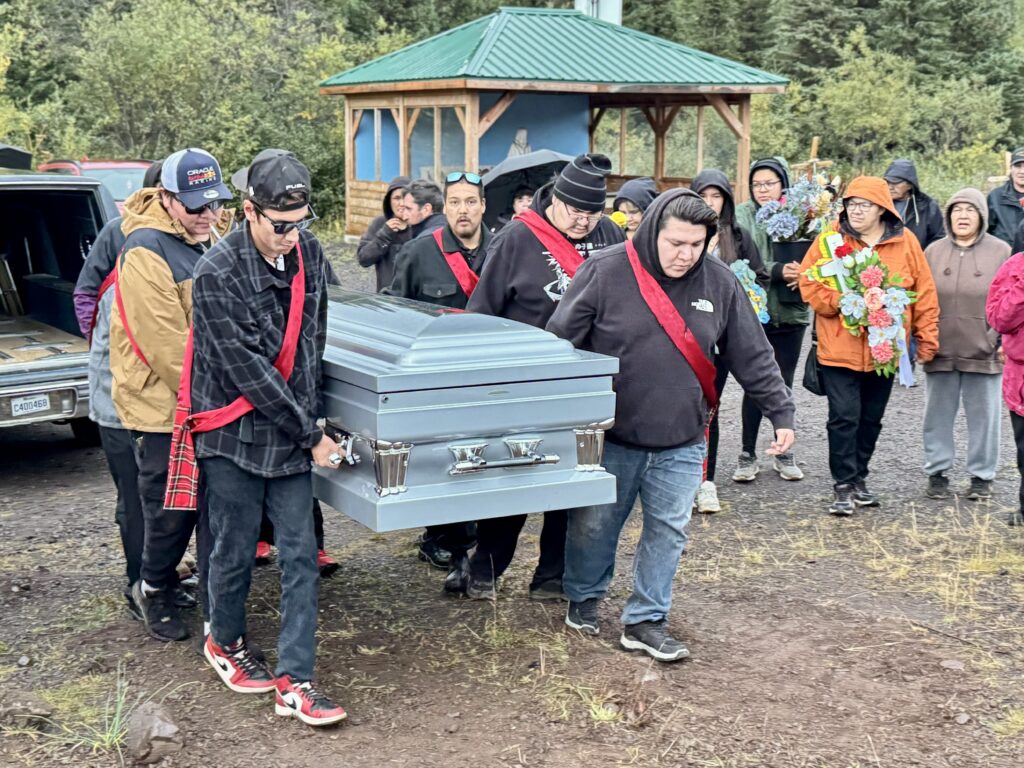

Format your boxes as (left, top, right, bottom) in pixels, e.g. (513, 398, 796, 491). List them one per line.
(324, 287, 618, 392)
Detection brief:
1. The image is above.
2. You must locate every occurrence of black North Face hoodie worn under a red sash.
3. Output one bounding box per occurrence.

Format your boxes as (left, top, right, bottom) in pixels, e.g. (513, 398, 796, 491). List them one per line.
(547, 189, 796, 450)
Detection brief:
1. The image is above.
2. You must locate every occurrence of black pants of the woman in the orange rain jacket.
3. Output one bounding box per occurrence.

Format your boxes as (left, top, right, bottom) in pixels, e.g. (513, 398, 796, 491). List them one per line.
(821, 366, 893, 485)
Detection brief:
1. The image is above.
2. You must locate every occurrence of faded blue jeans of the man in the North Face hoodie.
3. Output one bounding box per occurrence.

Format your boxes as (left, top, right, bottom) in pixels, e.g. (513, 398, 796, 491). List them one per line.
(562, 441, 707, 625)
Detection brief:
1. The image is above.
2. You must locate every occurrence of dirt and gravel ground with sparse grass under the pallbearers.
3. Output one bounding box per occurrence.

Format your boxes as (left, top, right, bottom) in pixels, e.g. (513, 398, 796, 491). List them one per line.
(0, 247, 1024, 768)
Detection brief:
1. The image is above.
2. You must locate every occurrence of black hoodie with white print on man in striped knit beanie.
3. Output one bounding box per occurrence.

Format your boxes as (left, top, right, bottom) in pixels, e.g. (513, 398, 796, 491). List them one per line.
(466, 184, 626, 328)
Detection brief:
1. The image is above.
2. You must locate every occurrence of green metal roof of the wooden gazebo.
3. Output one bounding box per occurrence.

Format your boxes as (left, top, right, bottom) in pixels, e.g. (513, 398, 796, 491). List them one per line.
(321, 8, 788, 89)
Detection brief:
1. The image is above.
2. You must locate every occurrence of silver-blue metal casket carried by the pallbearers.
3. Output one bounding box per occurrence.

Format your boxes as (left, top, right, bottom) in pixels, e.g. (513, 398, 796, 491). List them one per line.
(313, 288, 618, 531)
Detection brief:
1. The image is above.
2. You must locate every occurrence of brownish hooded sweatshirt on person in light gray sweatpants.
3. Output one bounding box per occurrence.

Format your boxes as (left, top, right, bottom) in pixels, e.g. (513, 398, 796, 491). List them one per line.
(925, 187, 1010, 374)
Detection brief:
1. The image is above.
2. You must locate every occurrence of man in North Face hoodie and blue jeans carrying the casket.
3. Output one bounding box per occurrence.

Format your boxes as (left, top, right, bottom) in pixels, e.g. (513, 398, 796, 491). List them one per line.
(547, 189, 795, 662)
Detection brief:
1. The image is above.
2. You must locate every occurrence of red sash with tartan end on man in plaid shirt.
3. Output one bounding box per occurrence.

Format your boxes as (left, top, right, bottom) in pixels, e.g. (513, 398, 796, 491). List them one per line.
(164, 244, 306, 511)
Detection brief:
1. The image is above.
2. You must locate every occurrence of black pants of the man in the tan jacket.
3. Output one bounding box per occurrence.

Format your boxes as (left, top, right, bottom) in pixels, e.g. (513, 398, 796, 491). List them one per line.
(131, 430, 195, 589)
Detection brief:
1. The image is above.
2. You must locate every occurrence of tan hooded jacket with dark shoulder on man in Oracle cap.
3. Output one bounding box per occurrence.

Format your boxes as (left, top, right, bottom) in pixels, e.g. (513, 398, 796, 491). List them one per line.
(111, 188, 231, 432)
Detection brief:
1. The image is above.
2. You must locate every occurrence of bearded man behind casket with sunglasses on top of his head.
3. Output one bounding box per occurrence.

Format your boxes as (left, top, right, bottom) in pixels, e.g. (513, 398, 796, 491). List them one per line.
(384, 171, 492, 581)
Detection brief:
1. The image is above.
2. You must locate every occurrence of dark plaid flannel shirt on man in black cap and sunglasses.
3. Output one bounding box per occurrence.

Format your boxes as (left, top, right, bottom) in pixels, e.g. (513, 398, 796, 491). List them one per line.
(191, 225, 329, 477)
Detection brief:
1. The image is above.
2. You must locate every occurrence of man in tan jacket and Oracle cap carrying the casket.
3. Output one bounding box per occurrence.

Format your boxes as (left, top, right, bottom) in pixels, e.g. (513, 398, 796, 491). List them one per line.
(110, 148, 231, 641)
